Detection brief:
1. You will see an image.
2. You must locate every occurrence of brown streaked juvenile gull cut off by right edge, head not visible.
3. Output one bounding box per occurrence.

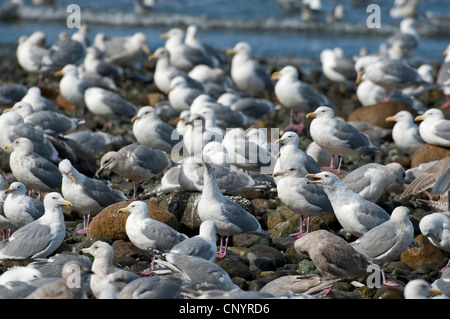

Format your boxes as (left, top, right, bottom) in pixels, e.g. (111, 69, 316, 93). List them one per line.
(400, 157, 450, 199)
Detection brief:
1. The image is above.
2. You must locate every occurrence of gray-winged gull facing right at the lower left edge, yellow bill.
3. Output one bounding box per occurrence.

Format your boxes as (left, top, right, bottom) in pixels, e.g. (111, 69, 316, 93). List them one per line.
(0, 192, 71, 260)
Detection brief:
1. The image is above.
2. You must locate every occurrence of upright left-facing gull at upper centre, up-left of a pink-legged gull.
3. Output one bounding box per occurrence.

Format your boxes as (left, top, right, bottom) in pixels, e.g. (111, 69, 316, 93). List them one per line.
(227, 41, 274, 97)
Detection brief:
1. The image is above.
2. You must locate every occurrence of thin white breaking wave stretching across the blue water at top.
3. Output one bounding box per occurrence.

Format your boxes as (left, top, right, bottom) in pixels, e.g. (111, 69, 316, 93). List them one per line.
(19, 6, 450, 37)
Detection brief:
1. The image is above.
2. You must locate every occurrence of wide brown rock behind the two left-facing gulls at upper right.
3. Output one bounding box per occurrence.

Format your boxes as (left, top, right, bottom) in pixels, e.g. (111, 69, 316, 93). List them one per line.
(347, 102, 417, 129)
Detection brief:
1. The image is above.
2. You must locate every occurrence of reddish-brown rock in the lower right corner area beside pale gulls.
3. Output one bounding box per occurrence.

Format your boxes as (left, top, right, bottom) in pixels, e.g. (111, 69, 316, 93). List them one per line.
(400, 235, 445, 269)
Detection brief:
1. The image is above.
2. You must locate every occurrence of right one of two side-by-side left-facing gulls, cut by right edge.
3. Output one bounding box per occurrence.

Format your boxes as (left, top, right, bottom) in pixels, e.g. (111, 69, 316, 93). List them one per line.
(415, 108, 450, 147)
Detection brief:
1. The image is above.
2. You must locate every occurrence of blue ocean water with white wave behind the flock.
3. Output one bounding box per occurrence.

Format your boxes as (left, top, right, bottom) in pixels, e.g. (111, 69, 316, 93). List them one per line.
(0, 0, 450, 67)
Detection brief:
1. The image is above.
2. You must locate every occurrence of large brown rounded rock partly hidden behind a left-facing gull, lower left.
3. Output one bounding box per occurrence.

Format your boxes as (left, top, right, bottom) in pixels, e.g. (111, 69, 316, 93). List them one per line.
(86, 201, 178, 240)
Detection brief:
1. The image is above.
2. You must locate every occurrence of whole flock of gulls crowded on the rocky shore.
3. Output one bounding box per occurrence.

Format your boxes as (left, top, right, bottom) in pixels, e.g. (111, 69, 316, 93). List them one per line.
(0, 3, 450, 299)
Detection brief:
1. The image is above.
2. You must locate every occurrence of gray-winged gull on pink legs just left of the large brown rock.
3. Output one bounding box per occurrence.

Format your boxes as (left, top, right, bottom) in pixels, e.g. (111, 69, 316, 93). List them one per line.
(58, 159, 127, 234)
